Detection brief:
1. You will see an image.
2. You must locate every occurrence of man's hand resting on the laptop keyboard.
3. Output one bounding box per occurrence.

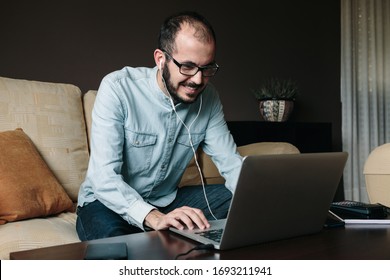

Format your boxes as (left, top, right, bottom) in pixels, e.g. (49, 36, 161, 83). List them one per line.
(145, 206, 210, 230)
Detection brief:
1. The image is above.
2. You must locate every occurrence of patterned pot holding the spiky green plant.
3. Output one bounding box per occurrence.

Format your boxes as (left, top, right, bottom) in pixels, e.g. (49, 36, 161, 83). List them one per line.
(259, 99, 294, 122)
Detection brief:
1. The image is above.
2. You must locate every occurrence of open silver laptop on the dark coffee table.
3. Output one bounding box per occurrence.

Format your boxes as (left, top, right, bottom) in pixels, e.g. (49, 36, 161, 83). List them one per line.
(170, 152, 348, 250)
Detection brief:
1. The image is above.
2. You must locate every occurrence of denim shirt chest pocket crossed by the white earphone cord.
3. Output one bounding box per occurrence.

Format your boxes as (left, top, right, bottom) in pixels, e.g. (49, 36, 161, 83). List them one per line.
(173, 133, 205, 170)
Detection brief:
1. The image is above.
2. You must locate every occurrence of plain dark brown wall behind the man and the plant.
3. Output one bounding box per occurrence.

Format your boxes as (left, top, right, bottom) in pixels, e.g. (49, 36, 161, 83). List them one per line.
(0, 0, 341, 150)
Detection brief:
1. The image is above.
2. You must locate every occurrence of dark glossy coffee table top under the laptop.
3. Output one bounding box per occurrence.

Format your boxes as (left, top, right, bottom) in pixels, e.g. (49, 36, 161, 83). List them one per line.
(10, 225, 390, 260)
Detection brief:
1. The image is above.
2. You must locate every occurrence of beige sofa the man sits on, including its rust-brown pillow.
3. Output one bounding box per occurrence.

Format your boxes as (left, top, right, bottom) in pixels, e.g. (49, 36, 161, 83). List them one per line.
(0, 77, 299, 259)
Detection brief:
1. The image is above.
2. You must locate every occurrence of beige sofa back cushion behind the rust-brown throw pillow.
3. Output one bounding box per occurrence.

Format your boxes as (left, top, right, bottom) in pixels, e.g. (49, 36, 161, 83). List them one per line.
(0, 77, 89, 202)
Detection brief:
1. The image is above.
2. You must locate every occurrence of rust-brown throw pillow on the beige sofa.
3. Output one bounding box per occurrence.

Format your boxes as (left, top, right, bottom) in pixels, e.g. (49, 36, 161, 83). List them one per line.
(0, 129, 73, 224)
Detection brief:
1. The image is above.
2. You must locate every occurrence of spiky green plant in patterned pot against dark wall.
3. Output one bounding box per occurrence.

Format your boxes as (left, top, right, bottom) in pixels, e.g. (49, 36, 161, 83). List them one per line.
(253, 78, 298, 122)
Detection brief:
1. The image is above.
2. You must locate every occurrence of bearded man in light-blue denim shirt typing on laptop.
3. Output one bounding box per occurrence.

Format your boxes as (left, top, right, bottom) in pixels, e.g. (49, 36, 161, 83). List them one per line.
(77, 12, 242, 240)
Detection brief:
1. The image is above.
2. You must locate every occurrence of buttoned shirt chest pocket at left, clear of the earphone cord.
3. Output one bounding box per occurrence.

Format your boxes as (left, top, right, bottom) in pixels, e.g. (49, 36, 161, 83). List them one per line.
(125, 129, 157, 173)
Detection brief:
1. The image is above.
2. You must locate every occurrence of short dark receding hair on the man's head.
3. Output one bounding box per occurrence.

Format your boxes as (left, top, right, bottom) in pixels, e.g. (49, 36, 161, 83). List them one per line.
(157, 11, 217, 53)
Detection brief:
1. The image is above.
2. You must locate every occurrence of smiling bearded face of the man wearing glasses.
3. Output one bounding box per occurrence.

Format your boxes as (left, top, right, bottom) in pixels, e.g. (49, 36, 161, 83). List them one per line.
(162, 24, 215, 104)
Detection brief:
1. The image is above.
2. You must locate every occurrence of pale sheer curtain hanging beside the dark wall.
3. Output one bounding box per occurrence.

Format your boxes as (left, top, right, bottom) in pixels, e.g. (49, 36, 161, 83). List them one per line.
(341, 0, 390, 202)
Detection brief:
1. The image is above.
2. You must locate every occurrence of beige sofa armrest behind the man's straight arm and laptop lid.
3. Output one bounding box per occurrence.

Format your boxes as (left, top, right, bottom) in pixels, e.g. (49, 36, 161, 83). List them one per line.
(179, 142, 300, 187)
